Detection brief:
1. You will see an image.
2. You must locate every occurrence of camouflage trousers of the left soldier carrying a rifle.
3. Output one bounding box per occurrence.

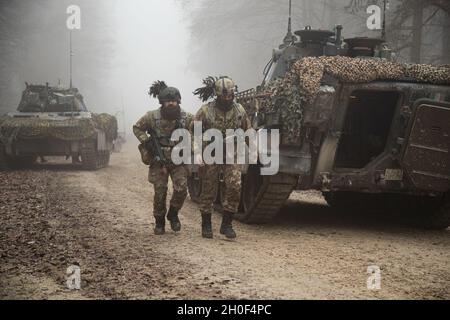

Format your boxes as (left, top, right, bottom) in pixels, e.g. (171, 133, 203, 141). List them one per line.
(148, 163, 187, 217)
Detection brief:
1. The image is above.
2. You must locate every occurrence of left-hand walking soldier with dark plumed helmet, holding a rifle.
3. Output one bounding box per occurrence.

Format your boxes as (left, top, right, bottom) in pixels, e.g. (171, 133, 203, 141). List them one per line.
(133, 82, 192, 235)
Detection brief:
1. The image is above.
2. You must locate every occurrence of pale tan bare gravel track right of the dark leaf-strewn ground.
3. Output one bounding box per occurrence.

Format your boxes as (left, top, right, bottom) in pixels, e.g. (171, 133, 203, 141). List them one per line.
(61, 145, 450, 299)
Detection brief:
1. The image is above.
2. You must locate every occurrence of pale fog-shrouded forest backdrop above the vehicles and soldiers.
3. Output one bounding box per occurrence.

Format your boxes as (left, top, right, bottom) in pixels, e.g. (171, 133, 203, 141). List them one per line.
(0, 0, 450, 131)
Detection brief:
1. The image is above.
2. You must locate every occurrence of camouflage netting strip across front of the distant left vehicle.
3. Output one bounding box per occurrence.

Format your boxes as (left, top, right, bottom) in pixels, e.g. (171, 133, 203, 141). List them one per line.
(0, 114, 117, 144)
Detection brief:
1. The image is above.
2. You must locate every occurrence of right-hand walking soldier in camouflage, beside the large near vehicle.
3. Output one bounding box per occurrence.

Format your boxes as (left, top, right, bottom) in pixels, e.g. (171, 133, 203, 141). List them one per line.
(194, 77, 251, 239)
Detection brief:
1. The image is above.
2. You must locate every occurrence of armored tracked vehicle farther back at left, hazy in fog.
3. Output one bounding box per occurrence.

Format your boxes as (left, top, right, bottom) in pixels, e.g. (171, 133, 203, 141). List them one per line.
(0, 84, 117, 170)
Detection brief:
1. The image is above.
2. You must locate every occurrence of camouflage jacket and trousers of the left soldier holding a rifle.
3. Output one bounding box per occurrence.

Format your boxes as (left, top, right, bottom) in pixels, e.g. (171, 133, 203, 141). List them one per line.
(133, 108, 192, 218)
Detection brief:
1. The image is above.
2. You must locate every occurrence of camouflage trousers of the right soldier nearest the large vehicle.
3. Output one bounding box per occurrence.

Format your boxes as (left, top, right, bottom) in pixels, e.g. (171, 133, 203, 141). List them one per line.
(199, 165, 241, 214)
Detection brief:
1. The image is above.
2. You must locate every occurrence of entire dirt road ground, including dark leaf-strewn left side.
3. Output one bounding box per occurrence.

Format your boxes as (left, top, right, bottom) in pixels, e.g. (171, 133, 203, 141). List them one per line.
(0, 147, 450, 299)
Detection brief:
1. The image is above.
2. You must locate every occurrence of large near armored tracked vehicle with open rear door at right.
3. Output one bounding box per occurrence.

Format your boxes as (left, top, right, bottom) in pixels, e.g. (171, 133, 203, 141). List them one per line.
(189, 19, 450, 229)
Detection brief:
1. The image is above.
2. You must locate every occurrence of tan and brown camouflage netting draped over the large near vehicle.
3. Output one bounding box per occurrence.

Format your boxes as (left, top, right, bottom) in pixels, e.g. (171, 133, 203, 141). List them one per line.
(258, 56, 450, 143)
